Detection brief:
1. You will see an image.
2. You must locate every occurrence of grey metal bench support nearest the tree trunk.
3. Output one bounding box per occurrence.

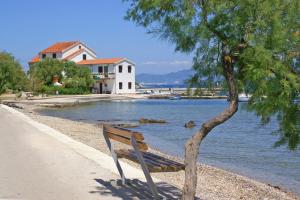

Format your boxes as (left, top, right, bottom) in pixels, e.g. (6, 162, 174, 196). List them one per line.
(131, 137, 161, 199)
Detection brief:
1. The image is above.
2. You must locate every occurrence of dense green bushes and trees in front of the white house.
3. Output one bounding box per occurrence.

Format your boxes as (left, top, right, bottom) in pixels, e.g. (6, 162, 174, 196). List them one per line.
(29, 58, 94, 94)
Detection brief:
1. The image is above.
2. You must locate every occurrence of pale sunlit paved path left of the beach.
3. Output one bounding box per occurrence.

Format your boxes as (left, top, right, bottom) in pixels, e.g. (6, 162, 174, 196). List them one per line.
(0, 106, 121, 200)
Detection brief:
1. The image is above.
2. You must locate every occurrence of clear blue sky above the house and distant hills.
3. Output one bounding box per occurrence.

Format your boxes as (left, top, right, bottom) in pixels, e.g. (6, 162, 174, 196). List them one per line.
(0, 0, 192, 74)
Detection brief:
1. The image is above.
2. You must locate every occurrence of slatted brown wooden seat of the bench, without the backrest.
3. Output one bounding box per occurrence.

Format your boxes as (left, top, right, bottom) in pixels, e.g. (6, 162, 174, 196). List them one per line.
(116, 149, 184, 172)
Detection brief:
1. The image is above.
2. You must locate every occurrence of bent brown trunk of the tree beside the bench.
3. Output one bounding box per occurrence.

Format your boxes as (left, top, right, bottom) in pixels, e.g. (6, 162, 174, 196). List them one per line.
(182, 54, 238, 200)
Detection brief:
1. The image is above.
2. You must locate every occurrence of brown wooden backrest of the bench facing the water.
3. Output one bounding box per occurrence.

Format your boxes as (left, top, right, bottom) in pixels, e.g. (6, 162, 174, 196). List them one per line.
(103, 125, 148, 151)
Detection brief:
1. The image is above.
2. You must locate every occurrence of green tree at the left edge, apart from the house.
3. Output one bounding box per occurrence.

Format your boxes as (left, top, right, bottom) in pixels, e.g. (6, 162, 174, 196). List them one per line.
(0, 52, 28, 94)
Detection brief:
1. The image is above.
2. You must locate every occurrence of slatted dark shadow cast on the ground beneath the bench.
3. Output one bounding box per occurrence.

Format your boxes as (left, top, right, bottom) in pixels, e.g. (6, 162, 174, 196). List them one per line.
(90, 179, 200, 200)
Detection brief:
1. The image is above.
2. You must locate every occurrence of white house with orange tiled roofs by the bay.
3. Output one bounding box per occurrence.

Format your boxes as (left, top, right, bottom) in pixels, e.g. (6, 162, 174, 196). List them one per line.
(29, 41, 135, 94)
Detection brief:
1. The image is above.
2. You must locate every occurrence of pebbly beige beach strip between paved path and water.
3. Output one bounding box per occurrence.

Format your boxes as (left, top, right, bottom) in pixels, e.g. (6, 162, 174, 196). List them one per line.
(9, 104, 300, 200)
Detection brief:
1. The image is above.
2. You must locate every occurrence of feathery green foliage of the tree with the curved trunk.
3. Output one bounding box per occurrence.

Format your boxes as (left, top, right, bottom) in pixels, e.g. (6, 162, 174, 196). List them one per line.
(126, 0, 300, 149)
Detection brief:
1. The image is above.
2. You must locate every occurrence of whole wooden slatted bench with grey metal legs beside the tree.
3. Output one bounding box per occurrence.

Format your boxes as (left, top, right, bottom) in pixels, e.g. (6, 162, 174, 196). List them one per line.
(103, 125, 185, 199)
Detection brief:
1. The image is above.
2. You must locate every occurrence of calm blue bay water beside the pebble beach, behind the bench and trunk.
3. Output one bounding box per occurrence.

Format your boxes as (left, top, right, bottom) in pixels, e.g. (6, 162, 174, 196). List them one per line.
(40, 100, 300, 194)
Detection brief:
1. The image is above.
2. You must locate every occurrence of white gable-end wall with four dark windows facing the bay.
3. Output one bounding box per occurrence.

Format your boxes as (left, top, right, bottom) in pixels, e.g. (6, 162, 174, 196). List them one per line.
(115, 61, 135, 94)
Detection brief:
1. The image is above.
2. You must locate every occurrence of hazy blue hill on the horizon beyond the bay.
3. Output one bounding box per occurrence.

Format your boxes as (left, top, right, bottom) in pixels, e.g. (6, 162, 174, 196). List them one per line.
(136, 69, 194, 85)
